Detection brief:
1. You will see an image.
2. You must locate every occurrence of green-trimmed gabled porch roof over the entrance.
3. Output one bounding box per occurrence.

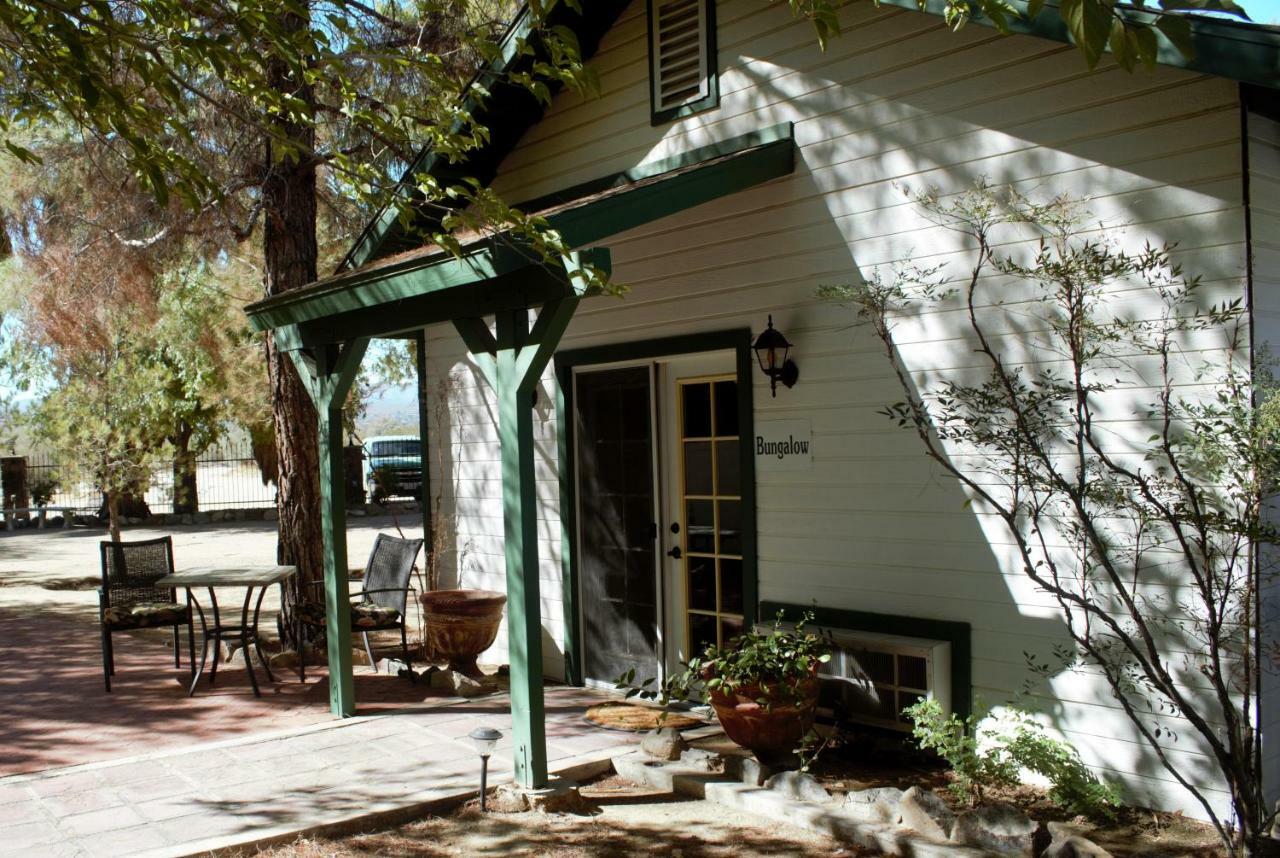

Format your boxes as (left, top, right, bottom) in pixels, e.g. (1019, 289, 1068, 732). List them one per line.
(246, 123, 795, 348)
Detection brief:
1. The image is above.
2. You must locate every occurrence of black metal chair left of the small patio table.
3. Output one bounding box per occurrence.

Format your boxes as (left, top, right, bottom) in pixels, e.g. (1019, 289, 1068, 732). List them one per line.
(97, 537, 204, 692)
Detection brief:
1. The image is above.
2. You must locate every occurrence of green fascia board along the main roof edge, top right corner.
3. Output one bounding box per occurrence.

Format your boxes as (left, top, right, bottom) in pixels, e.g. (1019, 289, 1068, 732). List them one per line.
(882, 0, 1280, 88)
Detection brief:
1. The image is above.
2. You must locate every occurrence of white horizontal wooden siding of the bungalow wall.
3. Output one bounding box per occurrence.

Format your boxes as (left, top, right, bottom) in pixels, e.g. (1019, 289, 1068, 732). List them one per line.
(428, 0, 1249, 813)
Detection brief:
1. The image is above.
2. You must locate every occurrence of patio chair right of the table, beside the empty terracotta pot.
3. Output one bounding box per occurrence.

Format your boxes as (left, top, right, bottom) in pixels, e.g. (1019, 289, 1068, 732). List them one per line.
(298, 533, 422, 683)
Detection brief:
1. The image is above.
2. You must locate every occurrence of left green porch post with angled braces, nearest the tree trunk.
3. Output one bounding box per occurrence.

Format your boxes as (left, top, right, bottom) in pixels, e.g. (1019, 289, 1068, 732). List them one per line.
(288, 339, 369, 718)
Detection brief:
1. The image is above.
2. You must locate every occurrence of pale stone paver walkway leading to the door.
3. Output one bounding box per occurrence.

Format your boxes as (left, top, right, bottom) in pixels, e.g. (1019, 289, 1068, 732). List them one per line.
(0, 688, 636, 858)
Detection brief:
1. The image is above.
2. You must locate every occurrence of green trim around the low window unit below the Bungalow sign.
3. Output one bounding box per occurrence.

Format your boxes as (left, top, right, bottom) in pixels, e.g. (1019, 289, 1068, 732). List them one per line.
(760, 602, 973, 718)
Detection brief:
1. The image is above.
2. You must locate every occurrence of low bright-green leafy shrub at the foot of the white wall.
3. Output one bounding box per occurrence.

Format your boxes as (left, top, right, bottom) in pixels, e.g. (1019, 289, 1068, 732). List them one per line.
(904, 700, 1120, 818)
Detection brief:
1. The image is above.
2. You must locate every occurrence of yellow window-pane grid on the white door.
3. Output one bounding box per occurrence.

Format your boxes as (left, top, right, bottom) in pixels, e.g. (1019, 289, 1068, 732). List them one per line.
(676, 374, 742, 654)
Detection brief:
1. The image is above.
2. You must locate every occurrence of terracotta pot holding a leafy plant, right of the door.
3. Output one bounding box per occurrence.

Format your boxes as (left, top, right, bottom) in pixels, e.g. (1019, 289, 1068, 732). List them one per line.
(709, 676, 818, 765)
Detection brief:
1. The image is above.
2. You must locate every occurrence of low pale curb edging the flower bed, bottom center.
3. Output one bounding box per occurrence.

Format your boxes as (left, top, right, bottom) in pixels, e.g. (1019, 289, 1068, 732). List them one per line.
(613, 750, 988, 858)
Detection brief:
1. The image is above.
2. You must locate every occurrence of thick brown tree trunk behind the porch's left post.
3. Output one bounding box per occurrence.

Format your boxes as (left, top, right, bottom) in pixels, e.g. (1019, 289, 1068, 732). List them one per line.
(262, 13, 324, 647)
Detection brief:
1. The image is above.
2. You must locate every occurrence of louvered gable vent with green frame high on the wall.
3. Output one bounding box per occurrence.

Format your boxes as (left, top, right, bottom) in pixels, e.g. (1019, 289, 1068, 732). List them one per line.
(650, 0, 713, 110)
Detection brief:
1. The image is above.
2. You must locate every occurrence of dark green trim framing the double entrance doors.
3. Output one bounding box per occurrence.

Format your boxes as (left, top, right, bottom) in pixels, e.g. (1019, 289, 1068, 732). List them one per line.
(556, 328, 759, 685)
